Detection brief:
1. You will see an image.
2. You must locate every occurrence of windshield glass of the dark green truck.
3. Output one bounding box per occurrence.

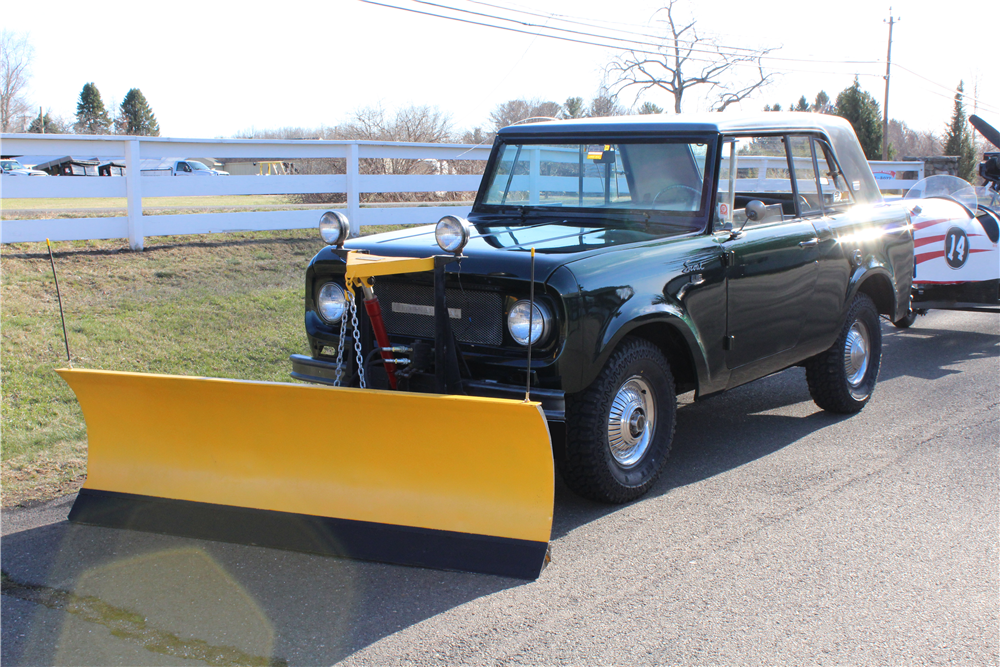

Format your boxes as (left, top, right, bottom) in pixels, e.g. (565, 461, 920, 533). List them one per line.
(480, 137, 709, 218)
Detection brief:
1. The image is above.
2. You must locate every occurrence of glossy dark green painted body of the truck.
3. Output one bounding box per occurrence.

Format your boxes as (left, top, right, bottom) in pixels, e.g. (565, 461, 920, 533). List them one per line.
(298, 124, 913, 404)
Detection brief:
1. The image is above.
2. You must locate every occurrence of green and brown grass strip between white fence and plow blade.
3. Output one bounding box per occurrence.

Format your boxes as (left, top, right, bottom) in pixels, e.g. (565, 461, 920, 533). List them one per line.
(0, 226, 418, 507)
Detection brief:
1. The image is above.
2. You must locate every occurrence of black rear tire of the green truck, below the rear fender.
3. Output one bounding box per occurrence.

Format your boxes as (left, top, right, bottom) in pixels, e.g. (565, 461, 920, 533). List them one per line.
(805, 294, 882, 414)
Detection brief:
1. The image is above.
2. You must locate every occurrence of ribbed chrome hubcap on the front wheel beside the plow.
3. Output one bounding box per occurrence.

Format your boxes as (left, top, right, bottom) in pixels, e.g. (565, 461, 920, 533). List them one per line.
(608, 375, 656, 468)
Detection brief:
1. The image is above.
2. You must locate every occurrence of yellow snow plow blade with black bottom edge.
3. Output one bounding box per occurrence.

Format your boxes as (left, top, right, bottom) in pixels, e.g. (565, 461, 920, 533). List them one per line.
(59, 370, 554, 579)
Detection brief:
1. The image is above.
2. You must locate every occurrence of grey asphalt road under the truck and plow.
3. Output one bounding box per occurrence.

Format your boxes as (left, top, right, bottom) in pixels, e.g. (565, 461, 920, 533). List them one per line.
(2, 311, 1000, 666)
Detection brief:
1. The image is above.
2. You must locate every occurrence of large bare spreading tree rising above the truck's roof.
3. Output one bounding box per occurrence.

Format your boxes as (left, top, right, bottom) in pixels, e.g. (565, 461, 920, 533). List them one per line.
(607, 0, 774, 113)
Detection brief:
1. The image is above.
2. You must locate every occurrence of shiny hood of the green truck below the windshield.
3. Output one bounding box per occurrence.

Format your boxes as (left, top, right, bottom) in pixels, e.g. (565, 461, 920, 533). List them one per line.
(345, 218, 680, 282)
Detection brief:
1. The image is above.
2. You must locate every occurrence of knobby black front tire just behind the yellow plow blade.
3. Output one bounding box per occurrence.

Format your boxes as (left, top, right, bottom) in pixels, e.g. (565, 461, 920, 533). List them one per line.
(557, 337, 677, 503)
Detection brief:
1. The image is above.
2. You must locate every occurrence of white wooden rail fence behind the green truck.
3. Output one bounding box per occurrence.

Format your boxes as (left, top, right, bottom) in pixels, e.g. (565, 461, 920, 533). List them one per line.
(0, 134, 924, 250)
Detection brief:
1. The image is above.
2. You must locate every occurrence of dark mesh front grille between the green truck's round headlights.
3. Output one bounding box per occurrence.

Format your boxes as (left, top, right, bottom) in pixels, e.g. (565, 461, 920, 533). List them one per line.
(375, 279, 503, 345)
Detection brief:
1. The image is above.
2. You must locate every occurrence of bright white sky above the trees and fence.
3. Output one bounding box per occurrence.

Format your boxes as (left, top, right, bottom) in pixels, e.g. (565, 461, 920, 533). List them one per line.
(0, 0, 1000, 138)
